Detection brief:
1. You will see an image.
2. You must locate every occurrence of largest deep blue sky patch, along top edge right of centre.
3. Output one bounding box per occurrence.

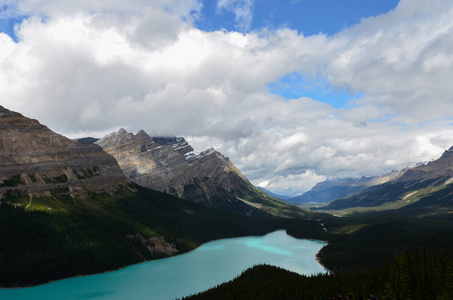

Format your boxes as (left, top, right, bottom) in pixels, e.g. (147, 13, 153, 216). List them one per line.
(200, 0, 398, 36)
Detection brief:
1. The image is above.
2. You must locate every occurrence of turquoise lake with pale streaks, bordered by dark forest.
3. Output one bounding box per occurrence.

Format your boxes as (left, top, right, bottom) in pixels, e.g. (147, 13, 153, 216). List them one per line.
(0, 230, 326, 300)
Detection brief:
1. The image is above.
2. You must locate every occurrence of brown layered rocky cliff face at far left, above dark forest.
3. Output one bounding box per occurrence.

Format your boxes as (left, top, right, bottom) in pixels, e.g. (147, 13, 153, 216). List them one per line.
(0, 106, 129, 201)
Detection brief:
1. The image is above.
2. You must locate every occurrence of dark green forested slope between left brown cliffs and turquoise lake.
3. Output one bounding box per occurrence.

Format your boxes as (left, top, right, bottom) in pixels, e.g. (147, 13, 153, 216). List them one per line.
(0, 186, 313, 287)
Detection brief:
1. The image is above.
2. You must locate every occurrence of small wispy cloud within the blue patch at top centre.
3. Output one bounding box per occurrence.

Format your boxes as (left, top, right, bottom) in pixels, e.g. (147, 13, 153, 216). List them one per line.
(217, 0, 254, 32)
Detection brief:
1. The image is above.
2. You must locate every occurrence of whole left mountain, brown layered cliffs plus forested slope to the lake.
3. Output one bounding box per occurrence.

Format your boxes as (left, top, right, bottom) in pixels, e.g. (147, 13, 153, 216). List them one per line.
(0, 106, 313, 287)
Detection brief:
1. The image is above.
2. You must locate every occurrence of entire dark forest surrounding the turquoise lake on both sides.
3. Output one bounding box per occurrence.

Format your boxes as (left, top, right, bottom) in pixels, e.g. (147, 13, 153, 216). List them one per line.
(0, 182, 453, 300)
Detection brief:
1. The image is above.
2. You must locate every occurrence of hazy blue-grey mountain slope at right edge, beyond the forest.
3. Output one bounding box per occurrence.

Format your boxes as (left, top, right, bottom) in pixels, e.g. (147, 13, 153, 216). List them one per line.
(313, 147, 453, 215)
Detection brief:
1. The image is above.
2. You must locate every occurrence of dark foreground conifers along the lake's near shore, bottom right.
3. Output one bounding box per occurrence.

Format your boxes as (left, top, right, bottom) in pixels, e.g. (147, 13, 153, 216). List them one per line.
(183, 249, 453, 300)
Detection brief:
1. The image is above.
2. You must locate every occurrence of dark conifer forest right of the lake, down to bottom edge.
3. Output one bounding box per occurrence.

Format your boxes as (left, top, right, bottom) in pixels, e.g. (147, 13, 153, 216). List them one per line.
(184, 215, 453, 300)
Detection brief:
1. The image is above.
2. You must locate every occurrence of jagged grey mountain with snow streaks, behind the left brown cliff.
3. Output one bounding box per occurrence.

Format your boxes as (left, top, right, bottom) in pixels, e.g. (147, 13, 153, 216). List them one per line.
(96, 129, 306, 216)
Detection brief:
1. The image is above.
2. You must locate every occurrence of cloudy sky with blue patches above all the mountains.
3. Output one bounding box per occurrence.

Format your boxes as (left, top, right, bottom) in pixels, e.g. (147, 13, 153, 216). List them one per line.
(0, 0, 453, 196)
